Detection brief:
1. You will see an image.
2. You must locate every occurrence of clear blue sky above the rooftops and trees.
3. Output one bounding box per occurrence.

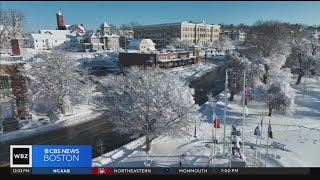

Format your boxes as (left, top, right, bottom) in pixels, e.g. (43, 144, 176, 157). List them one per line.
(0, 1, 320, 32)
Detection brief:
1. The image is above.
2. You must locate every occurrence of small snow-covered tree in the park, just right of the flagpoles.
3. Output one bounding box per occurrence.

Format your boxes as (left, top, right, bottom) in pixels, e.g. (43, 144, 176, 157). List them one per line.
(255, 82, 295, 116)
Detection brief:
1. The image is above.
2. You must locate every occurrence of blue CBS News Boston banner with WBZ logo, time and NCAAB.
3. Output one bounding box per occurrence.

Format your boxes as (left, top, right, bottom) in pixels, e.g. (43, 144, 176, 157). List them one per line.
(10, 145, 92, 174)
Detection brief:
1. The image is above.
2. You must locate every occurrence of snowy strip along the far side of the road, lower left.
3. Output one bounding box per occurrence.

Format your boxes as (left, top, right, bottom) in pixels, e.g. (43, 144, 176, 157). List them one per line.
(0, 105, 100, 143)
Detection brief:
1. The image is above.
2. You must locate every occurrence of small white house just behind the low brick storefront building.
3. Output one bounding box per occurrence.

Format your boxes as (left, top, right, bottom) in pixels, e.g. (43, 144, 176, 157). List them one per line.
(128, 39, 156, 52)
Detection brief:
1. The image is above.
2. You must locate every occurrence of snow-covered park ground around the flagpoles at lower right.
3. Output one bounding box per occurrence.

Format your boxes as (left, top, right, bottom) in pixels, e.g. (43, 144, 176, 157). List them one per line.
(93, 76, 320, 167)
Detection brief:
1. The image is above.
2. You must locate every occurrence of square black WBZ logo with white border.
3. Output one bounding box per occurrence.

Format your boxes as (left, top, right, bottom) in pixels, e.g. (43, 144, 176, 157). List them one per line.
(10, 145, 32, 167)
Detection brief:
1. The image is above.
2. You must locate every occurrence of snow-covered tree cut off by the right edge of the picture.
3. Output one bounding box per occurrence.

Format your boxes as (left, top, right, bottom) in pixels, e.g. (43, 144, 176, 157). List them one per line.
(291, 30, 320, 85)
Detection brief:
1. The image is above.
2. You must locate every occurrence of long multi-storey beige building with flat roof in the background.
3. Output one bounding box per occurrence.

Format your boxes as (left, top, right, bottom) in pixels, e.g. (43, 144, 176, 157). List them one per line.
(133, 21, 220, 47)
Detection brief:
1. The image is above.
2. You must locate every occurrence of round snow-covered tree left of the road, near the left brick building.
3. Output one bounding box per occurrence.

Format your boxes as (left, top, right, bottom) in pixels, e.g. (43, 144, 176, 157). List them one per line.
(26, 50, 89, 111)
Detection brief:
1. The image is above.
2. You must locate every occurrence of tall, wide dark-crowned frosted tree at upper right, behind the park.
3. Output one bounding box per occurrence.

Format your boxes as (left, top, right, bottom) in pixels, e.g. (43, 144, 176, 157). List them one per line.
(242, 21, 291, 84)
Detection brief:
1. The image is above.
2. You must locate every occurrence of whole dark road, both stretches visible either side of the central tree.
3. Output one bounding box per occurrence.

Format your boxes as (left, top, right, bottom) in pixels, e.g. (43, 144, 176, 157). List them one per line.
(0, 59, 224, 166)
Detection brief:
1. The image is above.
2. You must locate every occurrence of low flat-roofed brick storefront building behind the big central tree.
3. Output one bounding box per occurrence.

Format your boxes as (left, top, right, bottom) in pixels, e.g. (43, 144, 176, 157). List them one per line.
(119, 50, 200, 68)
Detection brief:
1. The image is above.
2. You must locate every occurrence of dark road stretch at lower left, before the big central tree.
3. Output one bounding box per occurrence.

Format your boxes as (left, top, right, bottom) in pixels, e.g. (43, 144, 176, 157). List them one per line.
(0, 116, 132, 166)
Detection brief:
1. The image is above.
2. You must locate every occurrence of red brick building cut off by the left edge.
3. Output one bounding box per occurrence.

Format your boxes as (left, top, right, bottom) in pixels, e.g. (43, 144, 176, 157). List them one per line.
(0, 62, 30, 132)
